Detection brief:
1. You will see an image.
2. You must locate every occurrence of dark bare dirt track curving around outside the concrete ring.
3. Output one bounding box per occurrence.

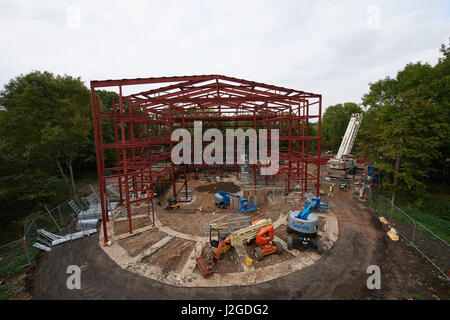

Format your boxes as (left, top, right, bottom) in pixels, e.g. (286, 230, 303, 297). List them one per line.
(27, 188, 450, 299)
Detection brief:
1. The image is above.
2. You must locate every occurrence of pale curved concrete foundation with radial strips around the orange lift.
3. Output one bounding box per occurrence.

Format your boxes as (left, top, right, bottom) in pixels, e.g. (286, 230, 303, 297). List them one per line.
(99, 200, 339, 287)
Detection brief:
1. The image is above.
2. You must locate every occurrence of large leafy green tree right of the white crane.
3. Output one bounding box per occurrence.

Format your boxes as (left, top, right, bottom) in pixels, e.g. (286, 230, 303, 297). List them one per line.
(360, 43, 449, 202)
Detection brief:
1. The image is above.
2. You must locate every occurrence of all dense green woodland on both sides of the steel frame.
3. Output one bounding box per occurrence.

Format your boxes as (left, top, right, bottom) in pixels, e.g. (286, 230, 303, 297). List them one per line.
(0, 45, 450, 243)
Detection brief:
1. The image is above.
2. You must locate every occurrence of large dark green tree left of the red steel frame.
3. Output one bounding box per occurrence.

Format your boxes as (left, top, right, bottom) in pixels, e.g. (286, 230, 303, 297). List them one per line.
(0, 71, 92, 234)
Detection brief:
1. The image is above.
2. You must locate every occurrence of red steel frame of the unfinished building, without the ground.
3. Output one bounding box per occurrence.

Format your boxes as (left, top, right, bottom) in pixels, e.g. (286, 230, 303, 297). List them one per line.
(91, 75, 327, 243)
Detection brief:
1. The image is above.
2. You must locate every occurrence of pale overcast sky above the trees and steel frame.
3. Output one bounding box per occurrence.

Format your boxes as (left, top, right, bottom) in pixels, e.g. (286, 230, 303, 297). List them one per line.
(0, 0, 450, 107)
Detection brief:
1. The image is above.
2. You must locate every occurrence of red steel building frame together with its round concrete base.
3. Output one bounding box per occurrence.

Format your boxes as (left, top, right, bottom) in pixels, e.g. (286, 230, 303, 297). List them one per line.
(87, 75, 338, 286)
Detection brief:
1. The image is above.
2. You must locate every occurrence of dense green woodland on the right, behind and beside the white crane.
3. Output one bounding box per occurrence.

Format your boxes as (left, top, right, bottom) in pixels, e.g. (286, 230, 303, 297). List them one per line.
(322, 45, 450, 240)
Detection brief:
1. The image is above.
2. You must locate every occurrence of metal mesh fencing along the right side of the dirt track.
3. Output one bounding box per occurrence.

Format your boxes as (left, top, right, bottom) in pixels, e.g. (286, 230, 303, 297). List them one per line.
(373, 195, 450, 281)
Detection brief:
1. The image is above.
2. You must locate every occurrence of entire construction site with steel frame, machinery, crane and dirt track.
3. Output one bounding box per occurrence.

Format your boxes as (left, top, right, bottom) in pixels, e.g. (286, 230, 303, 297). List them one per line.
(25, 75, 446, 299)
